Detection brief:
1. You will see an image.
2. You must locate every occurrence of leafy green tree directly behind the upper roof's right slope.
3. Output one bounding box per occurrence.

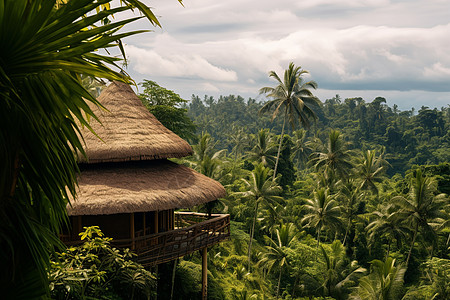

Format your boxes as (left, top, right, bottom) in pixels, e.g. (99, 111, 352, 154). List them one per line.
(139, 79, 196, 141)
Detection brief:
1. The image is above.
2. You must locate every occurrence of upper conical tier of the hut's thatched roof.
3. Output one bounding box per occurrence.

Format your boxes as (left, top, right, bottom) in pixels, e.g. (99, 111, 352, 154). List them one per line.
(79, 82, 192, 163)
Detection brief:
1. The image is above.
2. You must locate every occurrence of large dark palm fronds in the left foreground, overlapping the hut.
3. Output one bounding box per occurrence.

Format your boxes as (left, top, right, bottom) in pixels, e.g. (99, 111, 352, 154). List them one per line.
(0, 0, 150, 299)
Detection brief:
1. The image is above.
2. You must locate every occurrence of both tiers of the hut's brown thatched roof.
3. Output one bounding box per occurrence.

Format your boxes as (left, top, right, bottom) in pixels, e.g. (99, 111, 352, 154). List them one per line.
(67, 82, 225, 216)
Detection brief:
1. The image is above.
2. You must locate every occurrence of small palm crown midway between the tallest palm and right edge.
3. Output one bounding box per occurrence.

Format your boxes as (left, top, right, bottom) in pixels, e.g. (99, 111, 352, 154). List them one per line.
(356, 150, 387, 194)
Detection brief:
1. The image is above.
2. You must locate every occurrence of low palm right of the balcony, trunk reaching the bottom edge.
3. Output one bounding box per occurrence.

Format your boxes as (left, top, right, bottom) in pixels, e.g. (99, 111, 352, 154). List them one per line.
(258, 223, 297, 299)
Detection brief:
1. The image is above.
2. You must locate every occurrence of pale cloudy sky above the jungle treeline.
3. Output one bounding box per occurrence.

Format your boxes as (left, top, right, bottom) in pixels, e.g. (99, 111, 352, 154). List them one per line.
(119, 0, 450, 110)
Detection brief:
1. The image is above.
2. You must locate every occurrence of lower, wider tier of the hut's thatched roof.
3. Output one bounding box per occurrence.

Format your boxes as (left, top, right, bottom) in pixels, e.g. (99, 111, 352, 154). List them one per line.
(68, 160, 225, 216)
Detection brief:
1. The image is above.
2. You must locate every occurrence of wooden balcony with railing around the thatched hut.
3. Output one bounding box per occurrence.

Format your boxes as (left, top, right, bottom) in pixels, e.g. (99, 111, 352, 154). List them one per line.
(63, 212, 230, 267)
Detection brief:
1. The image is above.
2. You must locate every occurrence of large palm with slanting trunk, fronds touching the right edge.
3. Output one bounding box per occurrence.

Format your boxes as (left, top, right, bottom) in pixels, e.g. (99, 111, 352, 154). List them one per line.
(392, 169, 449, 266)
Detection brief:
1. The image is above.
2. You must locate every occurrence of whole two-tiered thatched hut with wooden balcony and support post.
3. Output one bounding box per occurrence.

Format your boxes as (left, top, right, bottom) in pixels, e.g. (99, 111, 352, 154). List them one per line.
(61, 82, 230, 282)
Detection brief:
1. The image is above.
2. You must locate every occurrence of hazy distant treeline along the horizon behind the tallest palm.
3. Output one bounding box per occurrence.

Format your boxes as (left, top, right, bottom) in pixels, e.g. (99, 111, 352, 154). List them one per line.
(185, 95, 450, 175)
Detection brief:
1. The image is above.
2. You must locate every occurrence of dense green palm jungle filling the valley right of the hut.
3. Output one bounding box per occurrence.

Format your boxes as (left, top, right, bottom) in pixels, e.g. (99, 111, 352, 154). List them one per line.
(185, 92, 450, 299)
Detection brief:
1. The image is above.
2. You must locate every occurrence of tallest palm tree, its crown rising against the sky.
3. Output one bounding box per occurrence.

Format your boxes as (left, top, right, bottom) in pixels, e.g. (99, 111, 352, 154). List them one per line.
(259, 62, 320, 178)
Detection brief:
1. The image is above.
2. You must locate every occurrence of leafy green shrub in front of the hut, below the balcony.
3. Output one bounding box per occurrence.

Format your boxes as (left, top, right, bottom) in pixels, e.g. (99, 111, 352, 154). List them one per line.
(48, 226, 156, 299)
